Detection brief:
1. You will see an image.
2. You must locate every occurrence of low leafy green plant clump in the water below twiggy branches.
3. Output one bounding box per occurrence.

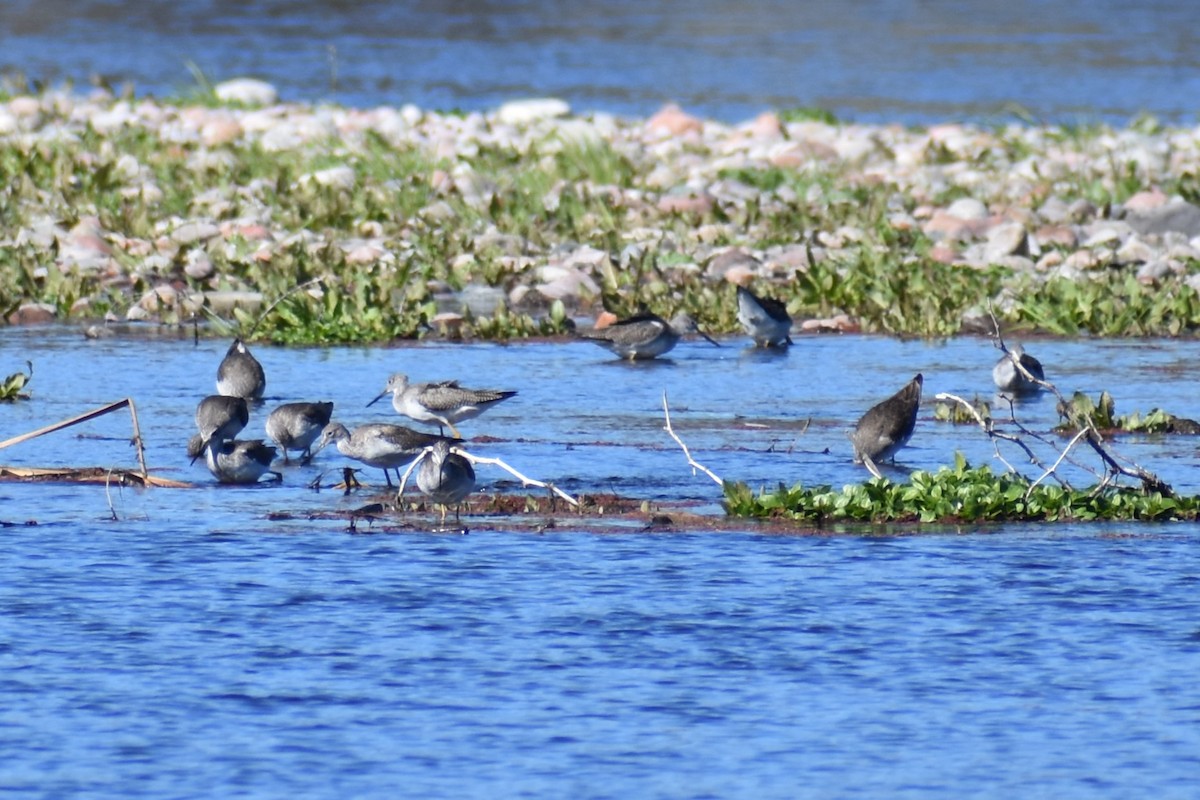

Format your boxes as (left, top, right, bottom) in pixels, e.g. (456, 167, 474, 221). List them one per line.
(724, 455, 1200, 525)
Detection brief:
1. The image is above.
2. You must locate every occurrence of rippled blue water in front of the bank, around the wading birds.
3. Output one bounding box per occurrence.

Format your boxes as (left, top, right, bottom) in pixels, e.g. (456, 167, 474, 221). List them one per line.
(0, 329, 1200, 798)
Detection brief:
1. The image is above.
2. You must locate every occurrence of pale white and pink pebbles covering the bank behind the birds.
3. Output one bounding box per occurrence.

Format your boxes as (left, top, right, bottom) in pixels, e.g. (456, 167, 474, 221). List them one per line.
(7, 89, 1200, 330)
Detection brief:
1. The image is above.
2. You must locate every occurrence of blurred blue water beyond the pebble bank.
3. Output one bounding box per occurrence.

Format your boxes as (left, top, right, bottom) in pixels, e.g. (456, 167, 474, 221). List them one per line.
(0, 0, 1200, 122)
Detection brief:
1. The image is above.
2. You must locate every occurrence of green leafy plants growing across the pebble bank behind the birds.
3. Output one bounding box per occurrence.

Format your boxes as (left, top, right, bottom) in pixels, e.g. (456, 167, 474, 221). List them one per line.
(7, 94, 1200, 343)
